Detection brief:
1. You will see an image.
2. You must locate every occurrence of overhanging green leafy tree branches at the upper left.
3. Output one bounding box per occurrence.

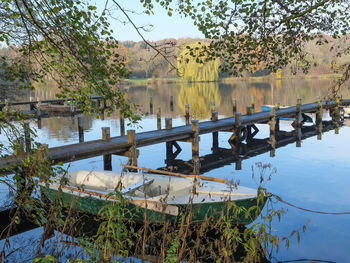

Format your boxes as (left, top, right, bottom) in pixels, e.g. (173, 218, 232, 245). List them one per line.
(0, 0, 135, 119)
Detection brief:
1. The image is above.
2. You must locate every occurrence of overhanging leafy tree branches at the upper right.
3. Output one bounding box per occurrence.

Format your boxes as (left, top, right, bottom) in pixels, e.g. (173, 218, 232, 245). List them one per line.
(140, 0, 350, 96)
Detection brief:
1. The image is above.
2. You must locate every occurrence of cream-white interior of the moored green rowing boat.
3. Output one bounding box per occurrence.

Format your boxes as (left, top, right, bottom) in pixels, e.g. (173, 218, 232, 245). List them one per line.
(50, 170, 256, 203)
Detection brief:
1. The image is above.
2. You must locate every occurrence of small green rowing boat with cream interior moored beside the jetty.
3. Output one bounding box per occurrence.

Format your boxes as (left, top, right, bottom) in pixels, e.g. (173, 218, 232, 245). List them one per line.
(42, 170, 266, 224)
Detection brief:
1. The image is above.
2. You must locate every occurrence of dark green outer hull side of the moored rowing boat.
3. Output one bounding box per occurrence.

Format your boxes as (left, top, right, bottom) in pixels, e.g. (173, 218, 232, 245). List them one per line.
(43, 187, 266, 225)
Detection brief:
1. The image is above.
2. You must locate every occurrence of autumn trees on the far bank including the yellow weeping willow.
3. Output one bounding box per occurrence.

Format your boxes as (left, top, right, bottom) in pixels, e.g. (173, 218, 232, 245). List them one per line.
(0, 36, 350, 82)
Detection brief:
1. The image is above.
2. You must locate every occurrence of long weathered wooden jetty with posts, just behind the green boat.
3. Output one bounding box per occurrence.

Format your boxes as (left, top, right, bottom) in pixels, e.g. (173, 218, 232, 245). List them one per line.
(0, 99, 350, 174)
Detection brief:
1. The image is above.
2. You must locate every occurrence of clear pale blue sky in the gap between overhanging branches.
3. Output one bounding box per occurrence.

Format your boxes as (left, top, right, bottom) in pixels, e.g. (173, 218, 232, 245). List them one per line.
(92, 0, 203, 41)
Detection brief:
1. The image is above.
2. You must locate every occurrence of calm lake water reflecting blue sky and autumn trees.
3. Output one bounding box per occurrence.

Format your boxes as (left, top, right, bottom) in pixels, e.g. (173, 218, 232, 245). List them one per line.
(1, 79, 350, 262)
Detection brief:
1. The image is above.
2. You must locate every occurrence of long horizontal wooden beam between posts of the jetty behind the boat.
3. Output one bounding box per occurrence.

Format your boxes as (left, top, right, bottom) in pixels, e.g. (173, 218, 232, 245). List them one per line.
(0, 100, 350, 169)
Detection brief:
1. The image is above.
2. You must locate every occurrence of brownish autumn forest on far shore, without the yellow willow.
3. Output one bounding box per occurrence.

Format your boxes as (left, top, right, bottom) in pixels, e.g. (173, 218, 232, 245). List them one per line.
(0, 36, 350, 81)
